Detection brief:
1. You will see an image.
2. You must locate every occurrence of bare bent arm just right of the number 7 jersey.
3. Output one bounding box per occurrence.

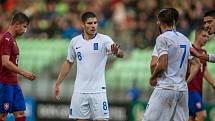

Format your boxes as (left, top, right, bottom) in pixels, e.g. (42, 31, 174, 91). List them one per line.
(187, 58, 200, 83)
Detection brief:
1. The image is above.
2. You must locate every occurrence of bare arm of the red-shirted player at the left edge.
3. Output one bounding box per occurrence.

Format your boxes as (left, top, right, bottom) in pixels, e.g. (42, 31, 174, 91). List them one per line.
(2, 55, 36, 81)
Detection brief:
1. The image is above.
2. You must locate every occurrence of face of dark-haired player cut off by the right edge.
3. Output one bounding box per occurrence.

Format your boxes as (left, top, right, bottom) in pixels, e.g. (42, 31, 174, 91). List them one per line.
(204, 16, 215, 35)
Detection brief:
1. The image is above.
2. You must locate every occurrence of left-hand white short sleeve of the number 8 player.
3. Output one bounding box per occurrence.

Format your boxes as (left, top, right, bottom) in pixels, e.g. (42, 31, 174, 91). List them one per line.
(67, 40, 76, 62)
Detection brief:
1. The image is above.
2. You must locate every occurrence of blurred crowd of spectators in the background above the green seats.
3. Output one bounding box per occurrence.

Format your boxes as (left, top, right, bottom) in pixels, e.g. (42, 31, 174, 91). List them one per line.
(0, 0, 215, 50)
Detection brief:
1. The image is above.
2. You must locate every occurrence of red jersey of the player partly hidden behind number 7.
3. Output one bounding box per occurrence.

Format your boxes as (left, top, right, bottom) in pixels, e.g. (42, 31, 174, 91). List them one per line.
(188, 45, 207, 94)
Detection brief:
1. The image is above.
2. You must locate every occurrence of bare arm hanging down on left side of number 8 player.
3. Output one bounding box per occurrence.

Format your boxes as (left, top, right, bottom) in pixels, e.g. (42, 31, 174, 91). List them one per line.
(55, 60, 73, 99)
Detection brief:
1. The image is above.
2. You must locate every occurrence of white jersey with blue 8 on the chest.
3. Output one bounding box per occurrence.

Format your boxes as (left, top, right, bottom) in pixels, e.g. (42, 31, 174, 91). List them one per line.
(67, 33, 114, 93)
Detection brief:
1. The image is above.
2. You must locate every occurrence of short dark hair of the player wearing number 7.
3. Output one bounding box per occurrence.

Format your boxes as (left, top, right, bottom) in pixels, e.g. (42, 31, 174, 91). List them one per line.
(158, 8, 179, 26)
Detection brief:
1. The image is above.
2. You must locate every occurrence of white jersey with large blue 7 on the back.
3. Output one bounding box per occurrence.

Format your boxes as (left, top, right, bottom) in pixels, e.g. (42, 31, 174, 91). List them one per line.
(153, 30, 190, 91)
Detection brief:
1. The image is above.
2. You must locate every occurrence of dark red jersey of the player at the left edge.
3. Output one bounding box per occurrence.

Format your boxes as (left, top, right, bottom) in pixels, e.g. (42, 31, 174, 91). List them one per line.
(0, 32, 19, 84)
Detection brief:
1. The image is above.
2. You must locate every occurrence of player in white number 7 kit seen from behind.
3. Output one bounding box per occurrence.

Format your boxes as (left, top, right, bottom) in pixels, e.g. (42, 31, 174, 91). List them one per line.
(143, 8, 190, 121)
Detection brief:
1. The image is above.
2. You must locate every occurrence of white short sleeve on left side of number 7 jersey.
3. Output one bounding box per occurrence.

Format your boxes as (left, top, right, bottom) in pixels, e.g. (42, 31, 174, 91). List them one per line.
(155, 36, 168, 57)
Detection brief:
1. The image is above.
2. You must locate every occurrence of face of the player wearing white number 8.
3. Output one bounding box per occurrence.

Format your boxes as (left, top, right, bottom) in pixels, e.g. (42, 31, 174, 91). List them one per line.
(83, 18, 98, 36)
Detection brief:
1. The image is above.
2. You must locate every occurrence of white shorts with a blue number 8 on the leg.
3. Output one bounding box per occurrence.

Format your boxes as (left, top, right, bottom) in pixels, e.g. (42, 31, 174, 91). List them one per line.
(69, 92, 109, 120)
